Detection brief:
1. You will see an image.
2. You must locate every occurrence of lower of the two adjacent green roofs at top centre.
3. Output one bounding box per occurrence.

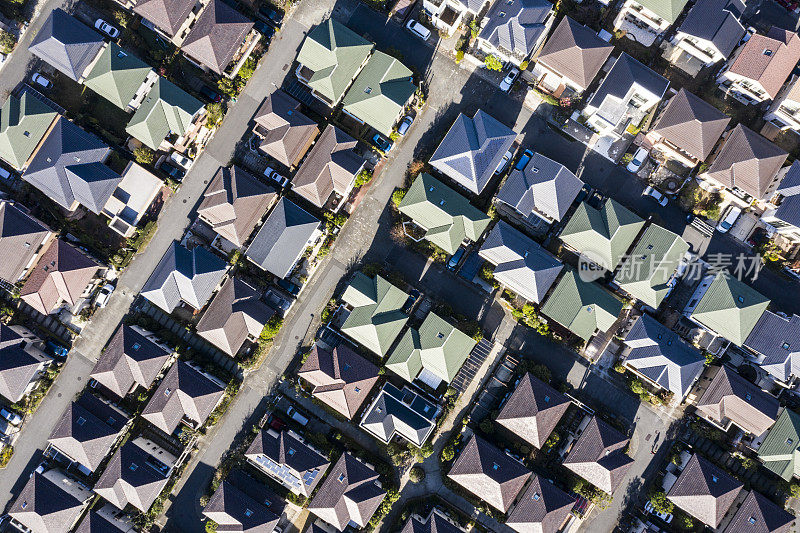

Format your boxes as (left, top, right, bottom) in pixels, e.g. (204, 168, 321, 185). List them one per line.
(342, 52, 417, 136)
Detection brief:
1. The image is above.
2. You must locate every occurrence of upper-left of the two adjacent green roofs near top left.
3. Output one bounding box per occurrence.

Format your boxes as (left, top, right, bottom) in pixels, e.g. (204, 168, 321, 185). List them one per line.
(83, 43, 153, 109)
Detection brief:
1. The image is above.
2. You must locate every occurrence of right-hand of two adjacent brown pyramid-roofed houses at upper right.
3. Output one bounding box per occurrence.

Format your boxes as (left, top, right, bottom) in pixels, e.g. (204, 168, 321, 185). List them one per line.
(699, 124, 788, 203)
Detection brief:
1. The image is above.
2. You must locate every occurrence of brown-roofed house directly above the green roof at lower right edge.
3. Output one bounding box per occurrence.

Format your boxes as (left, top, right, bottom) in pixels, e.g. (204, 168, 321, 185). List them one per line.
(696, 366, 780, 437)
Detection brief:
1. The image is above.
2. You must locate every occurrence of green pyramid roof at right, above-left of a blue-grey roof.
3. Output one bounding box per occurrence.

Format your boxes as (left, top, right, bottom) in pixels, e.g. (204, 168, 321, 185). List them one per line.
(691, 272, 769, 346)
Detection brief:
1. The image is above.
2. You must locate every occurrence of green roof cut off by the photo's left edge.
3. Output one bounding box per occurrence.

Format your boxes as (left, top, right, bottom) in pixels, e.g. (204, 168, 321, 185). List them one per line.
(0, 93, 58, 170)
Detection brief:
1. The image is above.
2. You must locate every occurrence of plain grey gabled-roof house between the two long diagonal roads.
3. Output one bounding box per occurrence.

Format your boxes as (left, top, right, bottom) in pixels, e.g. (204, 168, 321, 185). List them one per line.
(245, 198, 322, 278)
